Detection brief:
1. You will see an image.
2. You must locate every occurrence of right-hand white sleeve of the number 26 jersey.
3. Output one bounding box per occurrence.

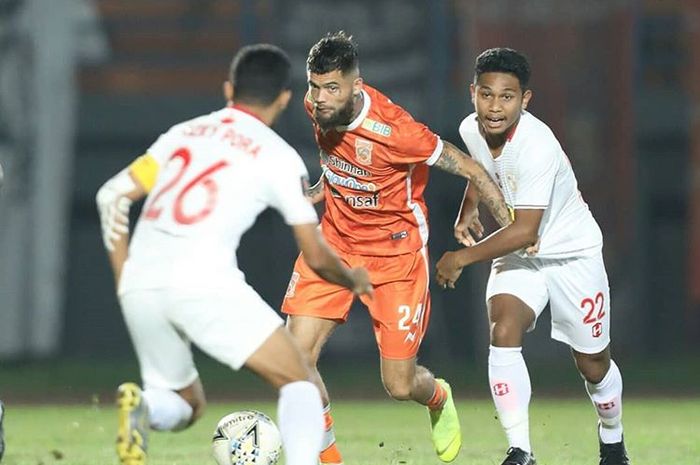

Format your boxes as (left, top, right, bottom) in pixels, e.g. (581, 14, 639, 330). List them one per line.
(264, 151, 318, 225)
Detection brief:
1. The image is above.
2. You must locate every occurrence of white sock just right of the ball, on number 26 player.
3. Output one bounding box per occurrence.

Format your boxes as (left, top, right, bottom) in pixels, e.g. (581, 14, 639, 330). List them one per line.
(277, 381, 324, 465)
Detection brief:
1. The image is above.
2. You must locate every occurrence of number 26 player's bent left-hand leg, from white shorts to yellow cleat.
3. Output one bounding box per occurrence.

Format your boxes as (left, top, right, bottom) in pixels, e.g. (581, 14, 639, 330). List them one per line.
(117, 290, 204, 465)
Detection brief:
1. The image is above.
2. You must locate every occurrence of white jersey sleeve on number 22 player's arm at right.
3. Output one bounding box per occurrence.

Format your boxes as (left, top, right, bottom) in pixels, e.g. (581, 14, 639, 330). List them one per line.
(513, 138, 561, 209)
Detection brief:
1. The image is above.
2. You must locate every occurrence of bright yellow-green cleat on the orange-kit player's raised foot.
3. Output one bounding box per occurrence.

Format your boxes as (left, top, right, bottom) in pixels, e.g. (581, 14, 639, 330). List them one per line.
(428, 379, 462, 462)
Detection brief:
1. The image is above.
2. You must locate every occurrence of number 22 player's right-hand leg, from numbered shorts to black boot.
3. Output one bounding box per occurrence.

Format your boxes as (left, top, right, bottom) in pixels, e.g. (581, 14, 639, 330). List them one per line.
(547, 254, 629, 465)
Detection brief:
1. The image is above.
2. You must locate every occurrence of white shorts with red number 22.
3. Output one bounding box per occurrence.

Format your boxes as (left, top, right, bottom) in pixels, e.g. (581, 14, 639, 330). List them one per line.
(486, 252, 610, 354)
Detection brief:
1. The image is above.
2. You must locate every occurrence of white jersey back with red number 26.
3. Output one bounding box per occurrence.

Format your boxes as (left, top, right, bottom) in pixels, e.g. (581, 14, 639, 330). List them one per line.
(120, 108, 316, 292)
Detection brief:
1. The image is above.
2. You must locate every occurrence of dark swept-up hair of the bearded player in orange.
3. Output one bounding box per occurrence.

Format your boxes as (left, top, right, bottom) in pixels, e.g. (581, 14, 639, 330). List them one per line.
(306, 31, 360, 74)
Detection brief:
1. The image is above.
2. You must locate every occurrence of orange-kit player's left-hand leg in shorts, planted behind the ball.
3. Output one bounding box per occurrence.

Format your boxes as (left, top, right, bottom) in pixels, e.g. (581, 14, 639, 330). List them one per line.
(282, 254, 353, 464)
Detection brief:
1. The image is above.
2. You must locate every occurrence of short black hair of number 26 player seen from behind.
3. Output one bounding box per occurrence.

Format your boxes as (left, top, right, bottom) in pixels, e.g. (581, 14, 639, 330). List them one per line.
(229, 44, 292, 105)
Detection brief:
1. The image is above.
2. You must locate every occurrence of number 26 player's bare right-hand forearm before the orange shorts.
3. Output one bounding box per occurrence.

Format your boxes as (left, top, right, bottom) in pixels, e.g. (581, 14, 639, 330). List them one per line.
(292, 223, 374, 297)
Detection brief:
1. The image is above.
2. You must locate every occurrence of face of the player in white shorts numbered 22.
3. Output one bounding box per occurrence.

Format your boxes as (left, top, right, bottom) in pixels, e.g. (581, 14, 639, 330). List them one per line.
(470, 73, 532, 136)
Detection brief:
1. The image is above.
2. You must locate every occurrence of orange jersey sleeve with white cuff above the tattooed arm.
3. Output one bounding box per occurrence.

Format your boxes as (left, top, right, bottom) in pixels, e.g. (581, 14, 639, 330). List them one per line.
(387, 111, 443, 165)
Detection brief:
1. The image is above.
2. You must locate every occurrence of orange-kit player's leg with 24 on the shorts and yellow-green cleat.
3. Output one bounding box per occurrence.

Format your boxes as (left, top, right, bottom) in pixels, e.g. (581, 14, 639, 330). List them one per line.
(370, 246, 462, 462)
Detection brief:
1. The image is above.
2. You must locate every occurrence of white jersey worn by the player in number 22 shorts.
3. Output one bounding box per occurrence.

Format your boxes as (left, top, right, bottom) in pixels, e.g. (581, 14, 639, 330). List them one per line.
(459, 112, 603, 258)
